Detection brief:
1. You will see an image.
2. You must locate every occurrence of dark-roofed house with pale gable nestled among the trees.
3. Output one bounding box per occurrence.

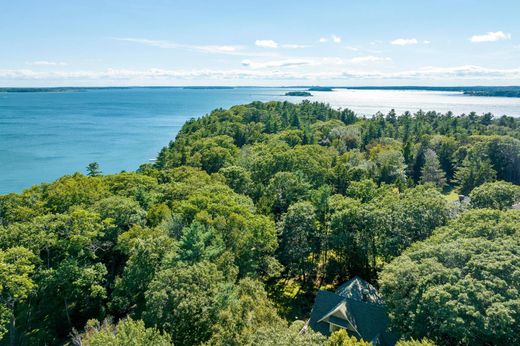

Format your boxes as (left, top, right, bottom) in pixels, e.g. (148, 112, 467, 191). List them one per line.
(308, 276, 398, 346)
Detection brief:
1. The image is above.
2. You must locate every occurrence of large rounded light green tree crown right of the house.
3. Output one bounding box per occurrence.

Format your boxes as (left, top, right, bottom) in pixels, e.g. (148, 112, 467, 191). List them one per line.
(380, 210, 520, 345)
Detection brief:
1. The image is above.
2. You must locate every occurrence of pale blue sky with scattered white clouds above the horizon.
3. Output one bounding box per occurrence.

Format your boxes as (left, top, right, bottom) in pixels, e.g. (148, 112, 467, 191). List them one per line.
(0, 0, 520, 87)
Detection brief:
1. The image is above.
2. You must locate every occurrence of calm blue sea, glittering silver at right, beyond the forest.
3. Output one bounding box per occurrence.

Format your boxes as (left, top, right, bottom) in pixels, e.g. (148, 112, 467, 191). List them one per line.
(0, 88, 520, 194)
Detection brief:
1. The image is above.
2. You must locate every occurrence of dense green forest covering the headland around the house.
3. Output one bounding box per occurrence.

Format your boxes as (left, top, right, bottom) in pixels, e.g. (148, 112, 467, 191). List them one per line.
(0, 101, 520, 346)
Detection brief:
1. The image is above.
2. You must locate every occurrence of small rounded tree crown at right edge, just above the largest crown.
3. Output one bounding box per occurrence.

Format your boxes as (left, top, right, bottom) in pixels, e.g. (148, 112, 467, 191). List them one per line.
(470, 181, 520, 209)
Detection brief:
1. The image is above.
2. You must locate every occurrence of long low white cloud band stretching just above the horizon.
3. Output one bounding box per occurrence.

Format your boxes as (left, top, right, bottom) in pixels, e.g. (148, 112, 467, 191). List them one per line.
(4, 65, 520, 83)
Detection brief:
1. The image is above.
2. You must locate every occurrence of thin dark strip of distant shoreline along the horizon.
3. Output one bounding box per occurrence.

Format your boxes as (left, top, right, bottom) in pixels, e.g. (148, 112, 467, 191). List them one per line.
(0, 86, 520, 97)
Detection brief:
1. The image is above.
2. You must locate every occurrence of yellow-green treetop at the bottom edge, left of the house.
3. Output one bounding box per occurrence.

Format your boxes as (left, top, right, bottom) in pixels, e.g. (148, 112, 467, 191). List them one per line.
(78, 318, 173, 346)
